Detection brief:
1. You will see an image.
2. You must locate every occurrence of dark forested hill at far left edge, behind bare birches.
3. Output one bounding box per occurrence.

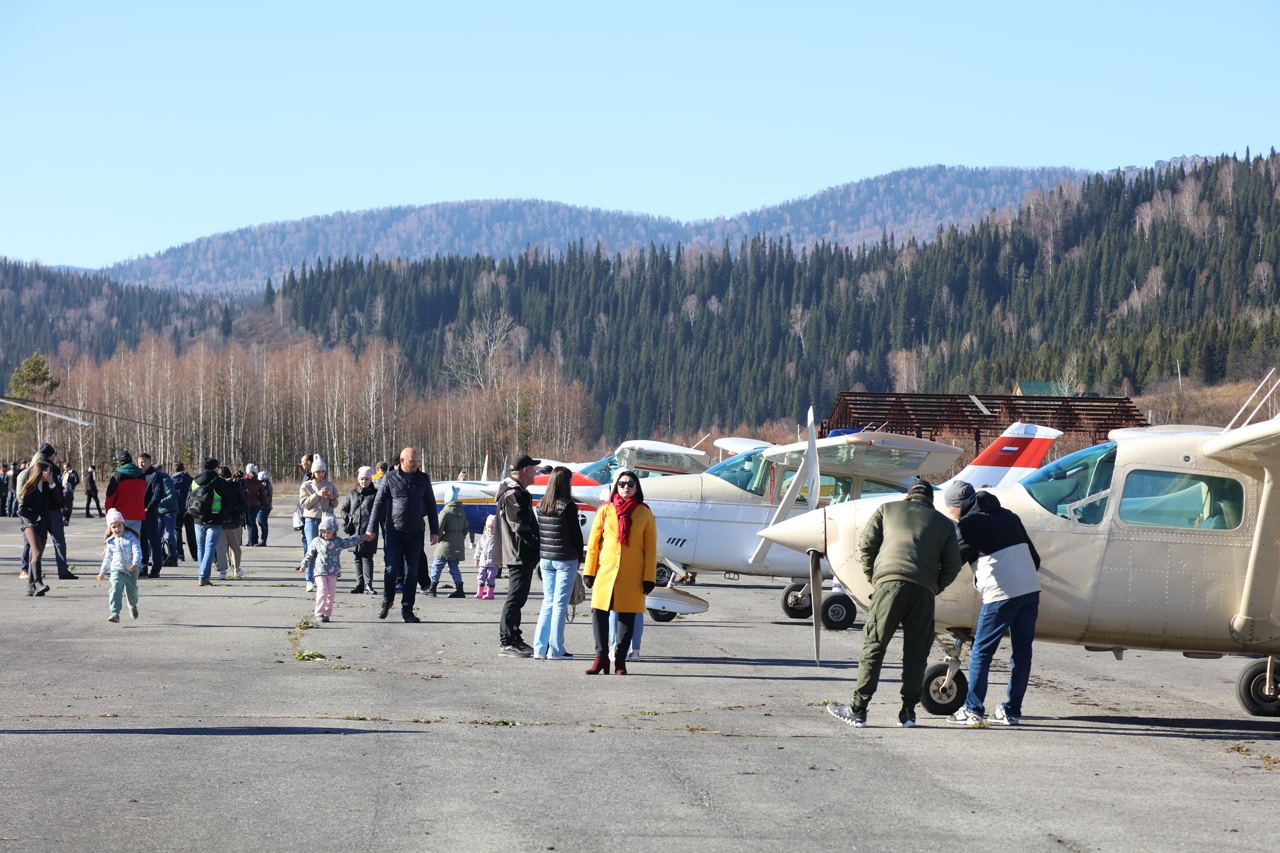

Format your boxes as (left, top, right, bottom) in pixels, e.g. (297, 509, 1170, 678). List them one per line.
(0, 257, 217, 377)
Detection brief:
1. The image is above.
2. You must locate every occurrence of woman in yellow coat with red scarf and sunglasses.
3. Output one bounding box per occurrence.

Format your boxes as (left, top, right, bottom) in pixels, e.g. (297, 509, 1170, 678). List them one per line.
(582, 471, 658, 675)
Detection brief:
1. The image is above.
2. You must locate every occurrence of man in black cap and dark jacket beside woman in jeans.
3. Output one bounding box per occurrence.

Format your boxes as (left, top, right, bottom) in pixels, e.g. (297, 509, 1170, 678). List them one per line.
(493, 453, 541, 657)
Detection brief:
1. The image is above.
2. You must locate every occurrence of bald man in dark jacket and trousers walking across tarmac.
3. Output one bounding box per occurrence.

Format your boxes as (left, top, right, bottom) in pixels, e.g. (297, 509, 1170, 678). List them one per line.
(365, 447, 440, 622)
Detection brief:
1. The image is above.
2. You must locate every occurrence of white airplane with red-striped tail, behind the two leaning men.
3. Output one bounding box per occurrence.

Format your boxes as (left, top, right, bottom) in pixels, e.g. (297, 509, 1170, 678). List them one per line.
(619, 412, 1061, 630)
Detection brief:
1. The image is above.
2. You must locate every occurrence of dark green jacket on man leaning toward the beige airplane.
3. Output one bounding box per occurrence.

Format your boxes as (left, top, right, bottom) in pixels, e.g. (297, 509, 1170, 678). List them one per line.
(858, 496, 960, 596)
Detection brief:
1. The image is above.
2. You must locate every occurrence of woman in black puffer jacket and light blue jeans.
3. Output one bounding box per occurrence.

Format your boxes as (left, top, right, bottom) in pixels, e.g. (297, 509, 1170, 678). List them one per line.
(534, 465, 582, 661)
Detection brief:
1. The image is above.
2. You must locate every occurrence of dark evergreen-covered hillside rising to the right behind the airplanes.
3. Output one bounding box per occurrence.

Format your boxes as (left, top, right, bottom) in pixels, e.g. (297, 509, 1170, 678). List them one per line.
(283, 151, 1280, 441)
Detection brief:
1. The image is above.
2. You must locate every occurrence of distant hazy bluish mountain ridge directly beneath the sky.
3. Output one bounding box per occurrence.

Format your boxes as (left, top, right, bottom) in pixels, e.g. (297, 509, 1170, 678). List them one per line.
(104, 167, 1085, 292)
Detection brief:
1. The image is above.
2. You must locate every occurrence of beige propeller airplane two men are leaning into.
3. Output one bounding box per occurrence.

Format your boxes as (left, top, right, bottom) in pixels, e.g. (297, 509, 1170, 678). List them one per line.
(760, 380, 1280, 716)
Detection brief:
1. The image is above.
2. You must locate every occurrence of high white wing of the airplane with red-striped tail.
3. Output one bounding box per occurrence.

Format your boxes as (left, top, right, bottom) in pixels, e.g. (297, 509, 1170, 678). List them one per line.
(763, 432, 964, 482)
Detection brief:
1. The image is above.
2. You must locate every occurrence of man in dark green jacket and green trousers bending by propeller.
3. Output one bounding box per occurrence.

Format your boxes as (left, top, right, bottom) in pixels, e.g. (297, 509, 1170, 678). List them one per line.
(827, 480, 960, 729)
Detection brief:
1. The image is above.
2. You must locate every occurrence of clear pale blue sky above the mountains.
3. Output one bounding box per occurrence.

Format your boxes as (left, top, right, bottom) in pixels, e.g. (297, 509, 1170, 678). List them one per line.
(0, 0, 1280, 266)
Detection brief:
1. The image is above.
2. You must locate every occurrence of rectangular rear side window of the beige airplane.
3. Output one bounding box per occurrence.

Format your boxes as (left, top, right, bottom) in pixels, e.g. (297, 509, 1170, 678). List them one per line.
(1120, 470, 1244, 530)
